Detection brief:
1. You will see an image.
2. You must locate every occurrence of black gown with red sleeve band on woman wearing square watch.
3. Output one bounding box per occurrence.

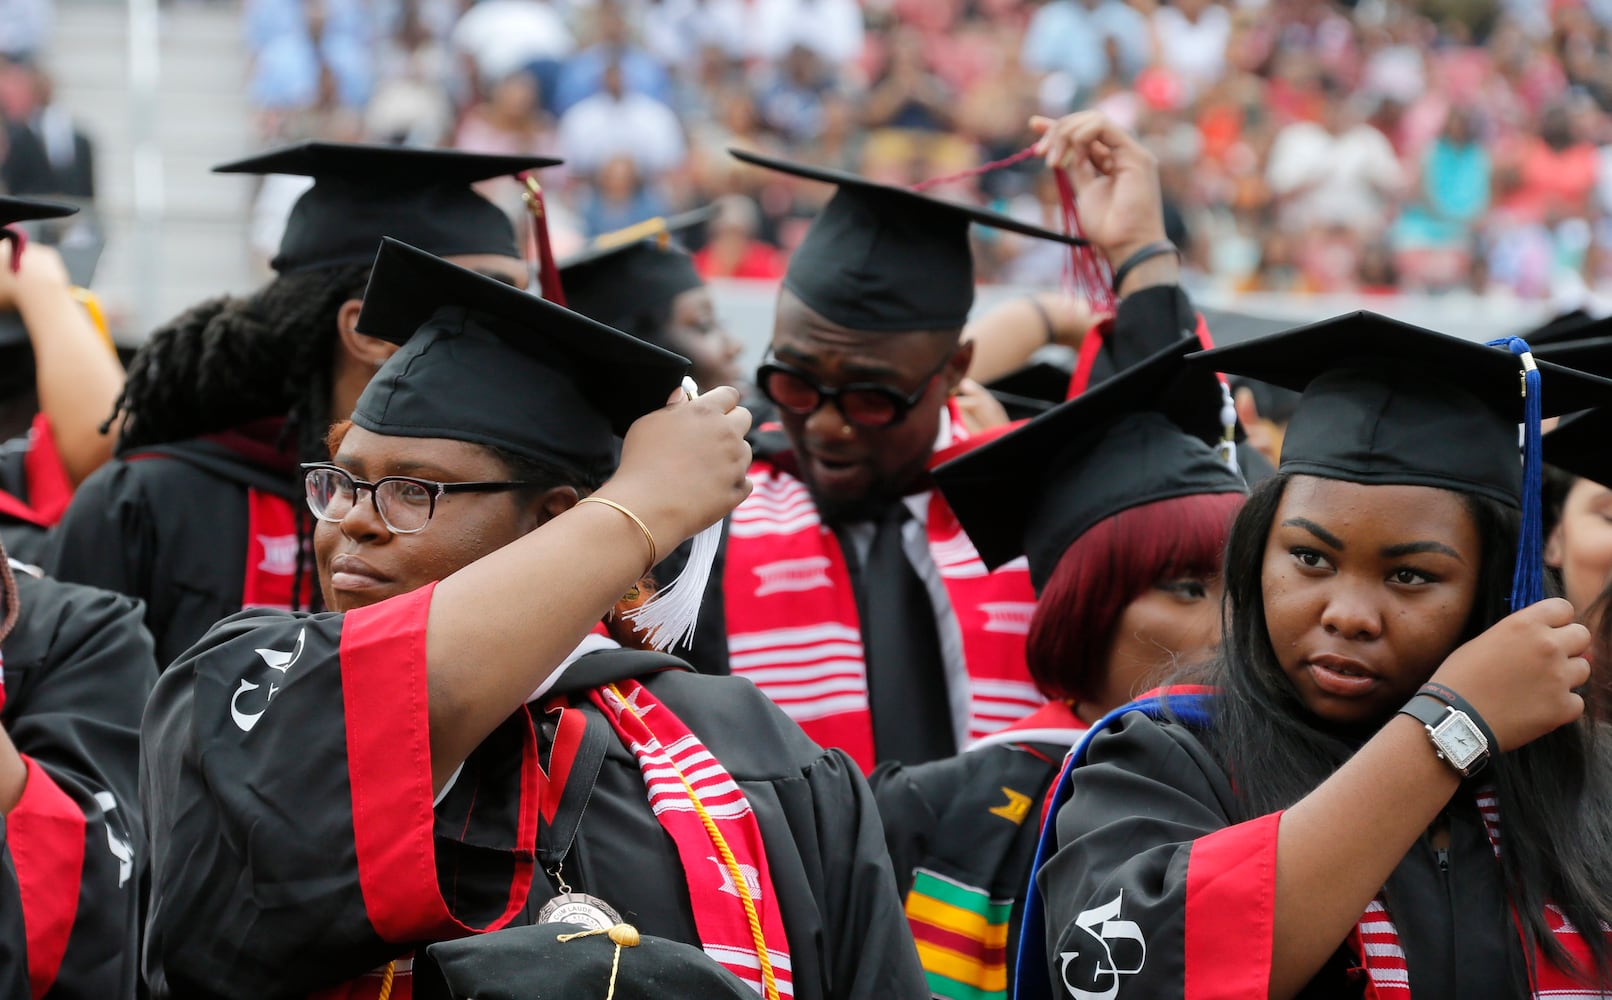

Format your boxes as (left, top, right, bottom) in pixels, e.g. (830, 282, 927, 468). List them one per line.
(1037, 711, 1527, 1000)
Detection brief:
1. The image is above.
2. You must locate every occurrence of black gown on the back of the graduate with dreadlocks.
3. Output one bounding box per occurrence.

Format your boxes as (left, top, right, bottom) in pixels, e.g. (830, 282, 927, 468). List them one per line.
(45, 439, 303, 669)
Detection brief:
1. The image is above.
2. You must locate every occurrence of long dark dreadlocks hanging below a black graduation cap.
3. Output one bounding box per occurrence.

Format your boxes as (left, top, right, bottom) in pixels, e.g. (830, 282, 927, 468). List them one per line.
(102, 263, 371, 610)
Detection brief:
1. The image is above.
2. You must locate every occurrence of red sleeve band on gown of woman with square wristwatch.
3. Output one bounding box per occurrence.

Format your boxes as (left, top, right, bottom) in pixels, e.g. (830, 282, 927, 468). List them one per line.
(1185, 813, 1282, 1000)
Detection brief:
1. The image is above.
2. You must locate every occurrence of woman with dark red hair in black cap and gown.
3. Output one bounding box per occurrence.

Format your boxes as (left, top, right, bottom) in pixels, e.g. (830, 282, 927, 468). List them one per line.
(870, 335, 1244, 1000)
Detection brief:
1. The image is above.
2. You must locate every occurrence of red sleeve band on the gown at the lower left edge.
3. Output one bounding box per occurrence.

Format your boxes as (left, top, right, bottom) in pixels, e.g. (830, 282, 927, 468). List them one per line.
(5, 756, 85, 998)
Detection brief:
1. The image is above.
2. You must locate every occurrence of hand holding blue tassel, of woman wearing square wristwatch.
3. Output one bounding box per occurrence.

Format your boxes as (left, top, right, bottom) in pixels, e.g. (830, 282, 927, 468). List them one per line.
(1433, 597, 1589, 750)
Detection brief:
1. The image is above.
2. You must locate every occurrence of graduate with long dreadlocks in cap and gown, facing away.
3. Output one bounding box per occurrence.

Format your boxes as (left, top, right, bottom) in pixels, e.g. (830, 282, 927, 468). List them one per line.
(45, 142, 555, 668)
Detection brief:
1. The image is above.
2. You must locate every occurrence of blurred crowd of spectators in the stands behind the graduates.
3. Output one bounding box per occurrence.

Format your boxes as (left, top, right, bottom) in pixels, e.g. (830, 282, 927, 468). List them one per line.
(15, 0, 1612, 306)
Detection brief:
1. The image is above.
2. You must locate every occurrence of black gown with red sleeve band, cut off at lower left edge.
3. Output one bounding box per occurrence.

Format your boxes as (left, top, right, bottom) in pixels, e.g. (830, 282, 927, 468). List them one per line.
(0, 573, 155, 1000)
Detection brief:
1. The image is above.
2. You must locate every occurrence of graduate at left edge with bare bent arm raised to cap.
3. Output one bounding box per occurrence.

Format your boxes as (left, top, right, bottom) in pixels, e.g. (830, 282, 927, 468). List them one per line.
(0, 197, 123, 563)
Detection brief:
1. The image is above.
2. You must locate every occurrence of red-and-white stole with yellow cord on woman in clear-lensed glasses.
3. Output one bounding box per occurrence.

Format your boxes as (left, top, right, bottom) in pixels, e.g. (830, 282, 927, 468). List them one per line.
(588, 679, 795, 1000)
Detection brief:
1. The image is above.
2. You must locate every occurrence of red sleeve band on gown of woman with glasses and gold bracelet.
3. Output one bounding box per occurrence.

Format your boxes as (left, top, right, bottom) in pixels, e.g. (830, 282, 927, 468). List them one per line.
(342, 584, 537, 944)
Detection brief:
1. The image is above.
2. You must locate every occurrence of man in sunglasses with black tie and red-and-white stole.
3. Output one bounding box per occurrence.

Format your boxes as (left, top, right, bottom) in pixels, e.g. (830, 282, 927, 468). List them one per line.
(709, 152, 1096, 769)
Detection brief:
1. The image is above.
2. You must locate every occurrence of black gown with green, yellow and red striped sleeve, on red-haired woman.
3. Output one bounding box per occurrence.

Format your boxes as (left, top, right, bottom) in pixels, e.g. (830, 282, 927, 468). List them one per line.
(869, 722, 1069, 1000)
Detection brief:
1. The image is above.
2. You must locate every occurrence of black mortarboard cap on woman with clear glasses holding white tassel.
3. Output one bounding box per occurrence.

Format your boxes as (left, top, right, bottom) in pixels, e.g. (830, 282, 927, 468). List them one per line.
(353, 239, 688, 471)
